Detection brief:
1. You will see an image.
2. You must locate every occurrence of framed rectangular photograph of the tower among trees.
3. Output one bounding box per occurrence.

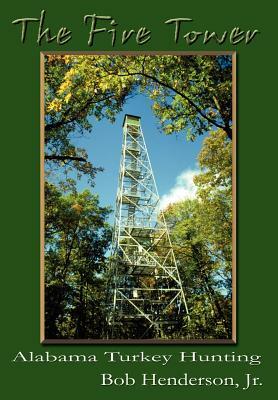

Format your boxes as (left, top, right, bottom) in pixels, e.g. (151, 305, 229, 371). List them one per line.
(41, 52, 236, 344)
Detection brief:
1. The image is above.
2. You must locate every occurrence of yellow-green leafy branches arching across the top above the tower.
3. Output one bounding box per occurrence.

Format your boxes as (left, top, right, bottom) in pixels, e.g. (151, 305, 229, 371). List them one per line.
(46, 55, 232, 139)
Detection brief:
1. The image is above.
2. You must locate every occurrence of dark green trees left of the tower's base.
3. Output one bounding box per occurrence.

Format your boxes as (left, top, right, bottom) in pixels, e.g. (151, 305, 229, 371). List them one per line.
(45, 183, 111, 339)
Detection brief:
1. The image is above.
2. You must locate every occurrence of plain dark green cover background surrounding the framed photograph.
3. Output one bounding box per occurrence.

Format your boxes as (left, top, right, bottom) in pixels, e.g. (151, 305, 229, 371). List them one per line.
(0, 0, 277, 399)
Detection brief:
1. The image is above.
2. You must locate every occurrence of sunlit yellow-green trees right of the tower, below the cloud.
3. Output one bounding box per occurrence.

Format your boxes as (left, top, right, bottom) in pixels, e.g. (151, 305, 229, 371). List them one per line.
(165, 131, 232, 339)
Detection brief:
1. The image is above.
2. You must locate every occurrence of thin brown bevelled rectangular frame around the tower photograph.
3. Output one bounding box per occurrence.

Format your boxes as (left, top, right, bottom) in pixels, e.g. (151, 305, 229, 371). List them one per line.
(40, 51, 237, 345)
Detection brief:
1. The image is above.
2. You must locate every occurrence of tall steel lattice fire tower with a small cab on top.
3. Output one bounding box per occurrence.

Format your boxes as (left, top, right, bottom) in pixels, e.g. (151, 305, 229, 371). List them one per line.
(109, 115, 188, 339)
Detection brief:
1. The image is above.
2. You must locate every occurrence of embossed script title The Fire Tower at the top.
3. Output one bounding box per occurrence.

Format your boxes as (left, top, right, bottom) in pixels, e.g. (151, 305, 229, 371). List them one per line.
(12, 10, 260, 47)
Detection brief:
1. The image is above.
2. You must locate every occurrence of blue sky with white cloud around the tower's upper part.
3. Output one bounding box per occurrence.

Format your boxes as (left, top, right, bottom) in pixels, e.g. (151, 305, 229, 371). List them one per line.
(75, 94, 204, 223)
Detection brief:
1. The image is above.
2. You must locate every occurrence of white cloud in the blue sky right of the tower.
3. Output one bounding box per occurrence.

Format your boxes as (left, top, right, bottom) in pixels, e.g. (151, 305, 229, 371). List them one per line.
(160, 169, 199, 210)
